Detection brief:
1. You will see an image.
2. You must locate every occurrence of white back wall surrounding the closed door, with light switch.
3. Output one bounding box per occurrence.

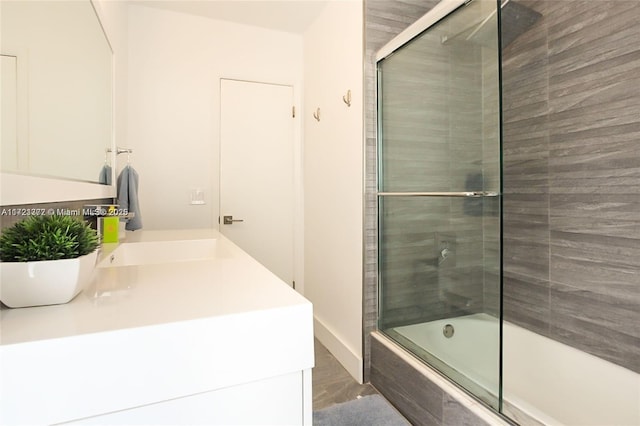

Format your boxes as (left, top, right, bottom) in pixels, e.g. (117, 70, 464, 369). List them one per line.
(128, 5, 302, 229)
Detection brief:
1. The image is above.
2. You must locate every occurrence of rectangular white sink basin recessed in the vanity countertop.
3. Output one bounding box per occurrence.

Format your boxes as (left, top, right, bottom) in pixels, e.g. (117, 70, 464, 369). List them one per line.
(97, 239, 217, 268)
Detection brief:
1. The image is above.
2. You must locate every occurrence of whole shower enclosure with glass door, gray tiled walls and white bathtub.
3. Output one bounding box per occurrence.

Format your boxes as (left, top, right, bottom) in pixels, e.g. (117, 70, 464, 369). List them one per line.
(372, 0, 640, 425)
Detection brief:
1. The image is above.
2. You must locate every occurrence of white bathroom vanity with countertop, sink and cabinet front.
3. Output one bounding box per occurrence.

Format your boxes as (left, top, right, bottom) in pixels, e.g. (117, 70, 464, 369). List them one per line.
(0, 230, 314, 425)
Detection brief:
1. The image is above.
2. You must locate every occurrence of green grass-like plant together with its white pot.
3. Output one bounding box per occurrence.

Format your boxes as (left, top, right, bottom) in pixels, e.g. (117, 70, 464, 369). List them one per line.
(0, 215, 99, 308)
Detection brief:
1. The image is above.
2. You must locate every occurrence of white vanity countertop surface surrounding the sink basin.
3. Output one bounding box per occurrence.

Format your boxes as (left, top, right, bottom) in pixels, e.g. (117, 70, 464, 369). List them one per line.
(0, 229, 309, 345)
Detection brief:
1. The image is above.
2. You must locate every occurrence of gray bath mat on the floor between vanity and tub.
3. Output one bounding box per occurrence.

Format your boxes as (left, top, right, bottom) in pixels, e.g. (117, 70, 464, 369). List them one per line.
(313, 395, 411, 426)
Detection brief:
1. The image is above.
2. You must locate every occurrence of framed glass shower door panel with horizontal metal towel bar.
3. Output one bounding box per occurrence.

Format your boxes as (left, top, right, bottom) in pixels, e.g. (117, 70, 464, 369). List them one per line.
(377, 0, 501, 409)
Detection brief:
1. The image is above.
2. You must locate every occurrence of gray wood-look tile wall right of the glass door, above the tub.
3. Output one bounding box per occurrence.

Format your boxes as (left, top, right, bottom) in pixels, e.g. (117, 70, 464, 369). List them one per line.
(503, 0, 640, 372)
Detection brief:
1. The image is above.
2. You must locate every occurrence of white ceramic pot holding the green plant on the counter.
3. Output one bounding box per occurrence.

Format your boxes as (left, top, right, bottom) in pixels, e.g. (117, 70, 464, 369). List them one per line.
(0, 250, 98, 308)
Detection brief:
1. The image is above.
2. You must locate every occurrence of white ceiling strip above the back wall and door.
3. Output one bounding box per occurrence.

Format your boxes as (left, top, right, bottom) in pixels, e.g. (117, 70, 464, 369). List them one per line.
(131, 0, 327, 34)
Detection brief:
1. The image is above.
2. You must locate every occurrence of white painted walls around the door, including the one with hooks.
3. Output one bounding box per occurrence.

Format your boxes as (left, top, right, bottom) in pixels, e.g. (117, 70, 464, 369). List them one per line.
(128, 5, 363, 381)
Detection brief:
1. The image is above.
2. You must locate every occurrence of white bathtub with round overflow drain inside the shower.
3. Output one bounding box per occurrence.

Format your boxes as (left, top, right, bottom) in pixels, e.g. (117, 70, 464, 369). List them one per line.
(390, 314, 640, 426)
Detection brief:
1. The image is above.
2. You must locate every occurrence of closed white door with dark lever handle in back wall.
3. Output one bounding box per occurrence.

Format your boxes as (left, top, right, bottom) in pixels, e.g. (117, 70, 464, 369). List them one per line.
(219, 79, 294, 285)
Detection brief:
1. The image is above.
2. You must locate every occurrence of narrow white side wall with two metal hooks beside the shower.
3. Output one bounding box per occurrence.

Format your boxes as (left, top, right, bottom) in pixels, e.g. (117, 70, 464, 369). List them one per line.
(304, 0, 364, 382)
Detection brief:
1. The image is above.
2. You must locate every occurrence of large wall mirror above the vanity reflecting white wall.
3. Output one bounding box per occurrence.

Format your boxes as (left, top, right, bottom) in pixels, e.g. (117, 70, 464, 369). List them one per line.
(0, 0, 112, 182)
